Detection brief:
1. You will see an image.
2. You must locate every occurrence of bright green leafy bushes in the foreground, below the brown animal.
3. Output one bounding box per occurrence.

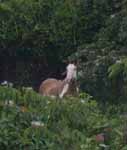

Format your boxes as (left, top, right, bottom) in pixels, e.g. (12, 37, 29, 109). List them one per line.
(0, 87, 126, 150)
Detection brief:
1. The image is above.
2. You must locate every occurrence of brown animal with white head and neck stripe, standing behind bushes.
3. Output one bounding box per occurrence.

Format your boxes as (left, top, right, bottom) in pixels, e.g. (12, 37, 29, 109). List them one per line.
(39, 64, 78, 98)
